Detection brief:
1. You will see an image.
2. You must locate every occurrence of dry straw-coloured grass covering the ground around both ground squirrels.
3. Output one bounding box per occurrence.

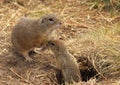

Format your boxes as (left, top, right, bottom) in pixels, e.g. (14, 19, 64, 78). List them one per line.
(0, 0, 120, 85)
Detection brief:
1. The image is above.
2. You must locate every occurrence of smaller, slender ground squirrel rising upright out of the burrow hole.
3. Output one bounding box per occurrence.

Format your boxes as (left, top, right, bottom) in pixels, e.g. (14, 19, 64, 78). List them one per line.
(48, 40, 81, 84)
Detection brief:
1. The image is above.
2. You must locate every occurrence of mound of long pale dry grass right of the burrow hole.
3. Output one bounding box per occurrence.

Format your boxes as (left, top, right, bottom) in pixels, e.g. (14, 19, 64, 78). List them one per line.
(66, 25, 120, 77)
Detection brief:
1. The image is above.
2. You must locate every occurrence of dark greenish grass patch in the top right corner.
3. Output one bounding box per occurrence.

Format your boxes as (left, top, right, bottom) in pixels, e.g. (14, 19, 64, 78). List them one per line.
(88, 0, 120, 16)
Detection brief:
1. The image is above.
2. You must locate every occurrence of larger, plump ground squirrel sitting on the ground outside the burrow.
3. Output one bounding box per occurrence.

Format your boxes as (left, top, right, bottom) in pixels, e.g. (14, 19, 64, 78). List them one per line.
(11, 14, 61, 62)
